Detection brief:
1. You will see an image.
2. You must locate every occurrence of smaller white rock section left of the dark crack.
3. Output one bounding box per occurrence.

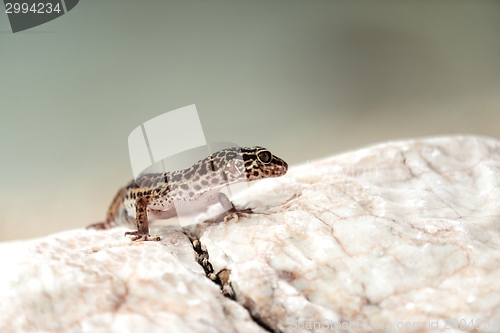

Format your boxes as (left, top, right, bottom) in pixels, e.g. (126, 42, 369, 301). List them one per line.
(0, 228, 265, 333)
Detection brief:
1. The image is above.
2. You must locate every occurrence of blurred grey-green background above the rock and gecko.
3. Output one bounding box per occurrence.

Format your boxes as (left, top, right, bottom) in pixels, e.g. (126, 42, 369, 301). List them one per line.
(0, 0, 500, 240)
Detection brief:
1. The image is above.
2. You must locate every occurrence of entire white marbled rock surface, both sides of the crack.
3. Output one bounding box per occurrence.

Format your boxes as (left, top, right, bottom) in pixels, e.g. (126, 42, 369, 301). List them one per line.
(0, 136, 500, 332)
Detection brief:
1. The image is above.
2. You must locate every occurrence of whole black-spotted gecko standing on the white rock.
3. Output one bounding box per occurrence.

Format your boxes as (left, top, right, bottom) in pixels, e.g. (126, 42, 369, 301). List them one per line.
(88, 146, 288, 241)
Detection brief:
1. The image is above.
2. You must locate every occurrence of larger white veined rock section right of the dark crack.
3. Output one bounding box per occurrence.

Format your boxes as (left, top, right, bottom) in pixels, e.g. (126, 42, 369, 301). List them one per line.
(201, 137, 500, 332)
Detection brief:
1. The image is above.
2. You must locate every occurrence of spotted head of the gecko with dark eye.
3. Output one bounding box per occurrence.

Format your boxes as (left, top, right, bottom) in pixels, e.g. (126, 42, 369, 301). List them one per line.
(241, 146, 288, 181)
